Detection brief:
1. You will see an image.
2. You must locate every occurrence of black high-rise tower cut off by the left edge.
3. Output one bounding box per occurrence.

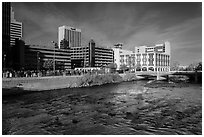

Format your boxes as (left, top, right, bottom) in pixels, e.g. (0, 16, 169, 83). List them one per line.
(2, 2, 11, 68)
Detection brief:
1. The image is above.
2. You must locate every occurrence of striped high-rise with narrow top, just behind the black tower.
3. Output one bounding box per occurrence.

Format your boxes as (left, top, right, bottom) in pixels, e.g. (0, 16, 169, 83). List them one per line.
(10, 7, 23, 47)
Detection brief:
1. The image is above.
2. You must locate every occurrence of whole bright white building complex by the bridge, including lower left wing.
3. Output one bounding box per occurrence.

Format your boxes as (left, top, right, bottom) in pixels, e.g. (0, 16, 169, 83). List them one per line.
(113, 42, 171, 71)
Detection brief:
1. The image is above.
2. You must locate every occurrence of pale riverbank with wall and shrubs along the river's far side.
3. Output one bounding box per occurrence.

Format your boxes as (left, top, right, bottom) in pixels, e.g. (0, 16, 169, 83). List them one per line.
(2, 73, 140, 95)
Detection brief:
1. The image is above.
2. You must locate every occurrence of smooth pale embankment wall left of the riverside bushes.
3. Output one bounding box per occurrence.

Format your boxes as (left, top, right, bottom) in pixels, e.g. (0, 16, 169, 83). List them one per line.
(2, 76, 81, 91)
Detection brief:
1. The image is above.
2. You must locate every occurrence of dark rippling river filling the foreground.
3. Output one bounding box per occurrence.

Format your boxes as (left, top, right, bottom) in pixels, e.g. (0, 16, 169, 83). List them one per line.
(2, 81, 202, 135)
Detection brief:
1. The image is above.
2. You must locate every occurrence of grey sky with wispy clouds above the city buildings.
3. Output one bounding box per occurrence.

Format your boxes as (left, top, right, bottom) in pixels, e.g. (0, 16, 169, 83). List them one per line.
(12, 2, 202, 65)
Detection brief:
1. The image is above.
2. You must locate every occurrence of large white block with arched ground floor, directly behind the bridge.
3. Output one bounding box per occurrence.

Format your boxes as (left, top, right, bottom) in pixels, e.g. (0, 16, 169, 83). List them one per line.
(135, 42, 171, 72)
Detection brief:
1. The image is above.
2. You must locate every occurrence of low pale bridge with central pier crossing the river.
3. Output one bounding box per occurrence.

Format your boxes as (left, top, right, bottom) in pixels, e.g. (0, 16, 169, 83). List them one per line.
(135, 71, 202, 83)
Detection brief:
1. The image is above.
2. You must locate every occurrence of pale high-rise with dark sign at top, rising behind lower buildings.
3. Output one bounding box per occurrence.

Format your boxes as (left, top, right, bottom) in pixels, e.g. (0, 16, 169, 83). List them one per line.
(58, 26, 81, 49)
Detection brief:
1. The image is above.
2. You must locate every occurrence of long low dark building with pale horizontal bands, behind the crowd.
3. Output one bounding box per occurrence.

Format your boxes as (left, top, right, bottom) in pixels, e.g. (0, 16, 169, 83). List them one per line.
(25, 45, 71, 70)
